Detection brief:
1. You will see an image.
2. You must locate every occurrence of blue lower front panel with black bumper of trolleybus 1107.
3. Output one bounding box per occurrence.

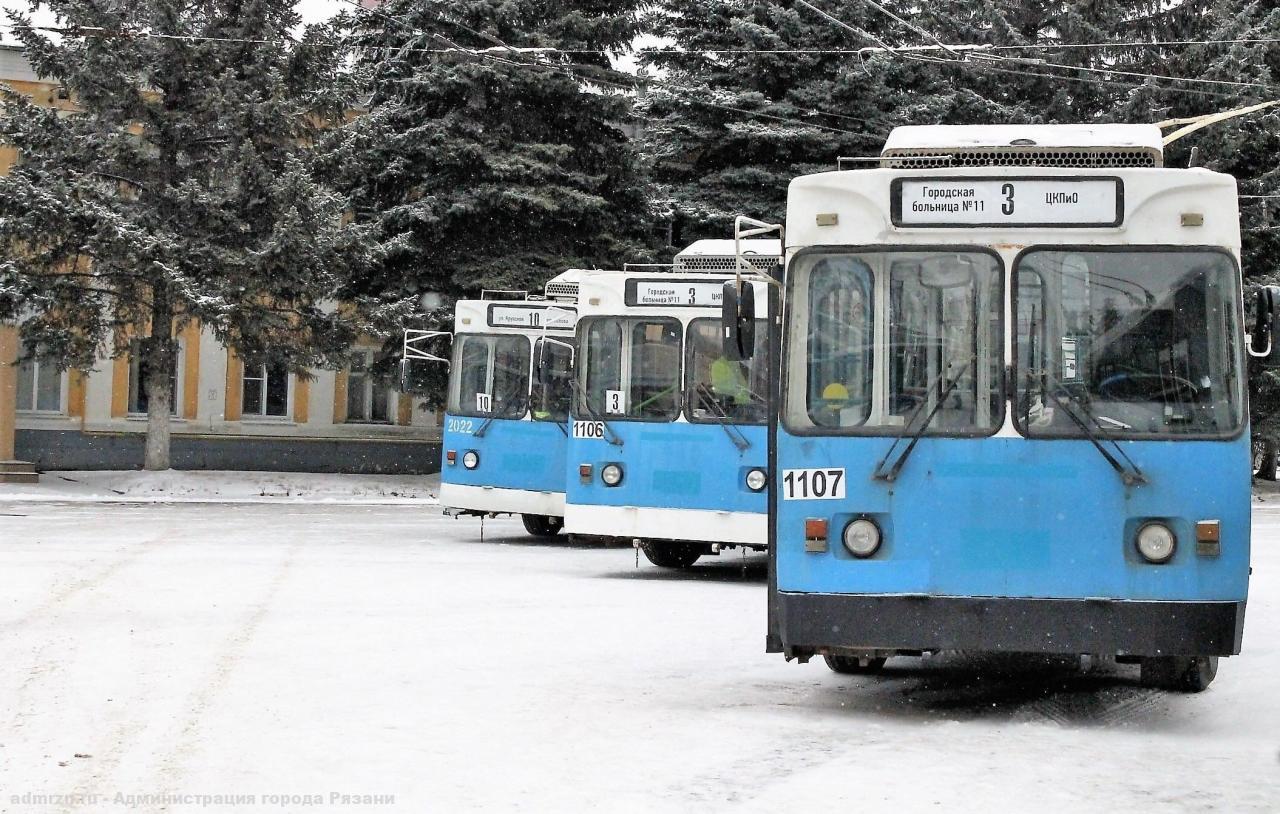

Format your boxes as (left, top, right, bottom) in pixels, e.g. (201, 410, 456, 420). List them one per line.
(771, 430, 1249, 655)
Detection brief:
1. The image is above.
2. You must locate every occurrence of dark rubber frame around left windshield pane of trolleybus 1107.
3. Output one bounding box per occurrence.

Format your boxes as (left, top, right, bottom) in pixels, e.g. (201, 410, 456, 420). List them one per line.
(778, 243, 1010, 439)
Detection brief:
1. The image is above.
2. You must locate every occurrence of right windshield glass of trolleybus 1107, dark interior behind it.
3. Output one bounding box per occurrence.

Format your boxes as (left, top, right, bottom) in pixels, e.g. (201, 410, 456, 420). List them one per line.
(1014, 247, 1244, 438)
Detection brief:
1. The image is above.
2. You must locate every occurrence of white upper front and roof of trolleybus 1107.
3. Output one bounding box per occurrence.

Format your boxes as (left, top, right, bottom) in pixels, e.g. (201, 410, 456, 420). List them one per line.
(786, 124, 1240, 250)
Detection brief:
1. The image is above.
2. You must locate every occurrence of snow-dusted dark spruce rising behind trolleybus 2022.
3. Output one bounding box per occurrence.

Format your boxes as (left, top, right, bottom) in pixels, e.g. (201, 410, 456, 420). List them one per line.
(326, 0, 649, 307)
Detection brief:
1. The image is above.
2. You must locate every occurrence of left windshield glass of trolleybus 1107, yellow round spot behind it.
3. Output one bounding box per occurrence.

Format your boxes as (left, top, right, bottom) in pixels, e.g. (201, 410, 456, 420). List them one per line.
(786, 250, 1004, 435)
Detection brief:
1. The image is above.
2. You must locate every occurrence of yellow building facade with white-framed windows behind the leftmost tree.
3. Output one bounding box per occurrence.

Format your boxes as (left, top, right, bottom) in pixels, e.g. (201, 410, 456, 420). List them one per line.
(0, 46, 439, 473)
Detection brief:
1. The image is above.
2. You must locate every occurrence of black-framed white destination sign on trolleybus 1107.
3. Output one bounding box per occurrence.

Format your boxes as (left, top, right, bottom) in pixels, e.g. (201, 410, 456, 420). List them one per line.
(891, 177, 1124, 227)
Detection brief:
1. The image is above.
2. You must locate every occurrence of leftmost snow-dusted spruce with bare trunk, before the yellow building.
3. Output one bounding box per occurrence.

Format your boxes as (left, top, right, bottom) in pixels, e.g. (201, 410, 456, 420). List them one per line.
(0, 0, 394, 468)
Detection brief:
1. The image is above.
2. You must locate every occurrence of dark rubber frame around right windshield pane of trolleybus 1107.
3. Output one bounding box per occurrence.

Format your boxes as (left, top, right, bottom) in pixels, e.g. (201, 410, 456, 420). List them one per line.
(1006, 243, 1249, 443)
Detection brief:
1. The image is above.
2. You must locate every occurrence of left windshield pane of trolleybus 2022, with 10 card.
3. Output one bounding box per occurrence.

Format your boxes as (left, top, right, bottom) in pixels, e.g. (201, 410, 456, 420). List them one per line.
(449, 334, 530, 419)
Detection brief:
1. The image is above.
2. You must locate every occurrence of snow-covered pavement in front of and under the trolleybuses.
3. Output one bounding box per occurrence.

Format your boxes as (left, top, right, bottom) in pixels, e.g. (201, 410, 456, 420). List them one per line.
(0, 499, 1280, 814)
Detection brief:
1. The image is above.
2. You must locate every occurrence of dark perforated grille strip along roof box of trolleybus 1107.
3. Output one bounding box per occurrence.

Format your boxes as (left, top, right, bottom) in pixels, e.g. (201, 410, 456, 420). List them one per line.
(882, 147, 1164, 169)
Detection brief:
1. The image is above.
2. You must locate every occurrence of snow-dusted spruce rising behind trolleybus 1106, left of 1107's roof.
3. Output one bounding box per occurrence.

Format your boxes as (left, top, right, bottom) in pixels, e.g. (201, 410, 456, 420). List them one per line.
(640, 0, 895, 248)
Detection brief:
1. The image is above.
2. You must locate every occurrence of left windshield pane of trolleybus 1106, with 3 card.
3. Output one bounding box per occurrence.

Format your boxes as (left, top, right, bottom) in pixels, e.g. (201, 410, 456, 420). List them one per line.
(580, 316, 680, 421)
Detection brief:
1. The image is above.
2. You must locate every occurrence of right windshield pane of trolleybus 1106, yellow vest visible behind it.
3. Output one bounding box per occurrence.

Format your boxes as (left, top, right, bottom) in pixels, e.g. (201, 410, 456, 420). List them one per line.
(685, 319, 769, 424)
